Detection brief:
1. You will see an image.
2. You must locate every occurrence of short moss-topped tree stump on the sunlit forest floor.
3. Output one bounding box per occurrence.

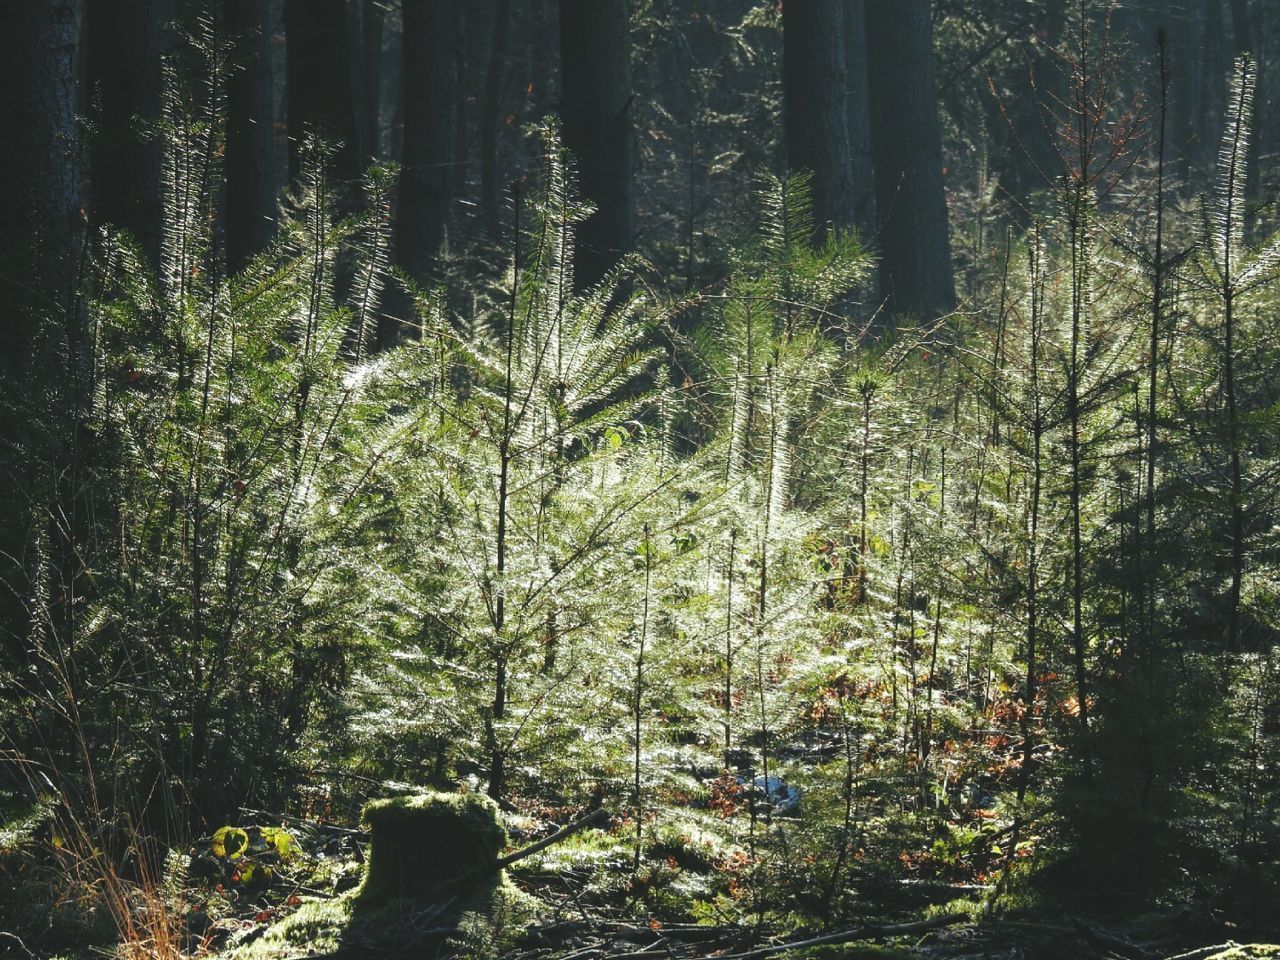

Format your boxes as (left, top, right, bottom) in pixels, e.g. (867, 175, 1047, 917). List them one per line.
(360, 794, 507, 905)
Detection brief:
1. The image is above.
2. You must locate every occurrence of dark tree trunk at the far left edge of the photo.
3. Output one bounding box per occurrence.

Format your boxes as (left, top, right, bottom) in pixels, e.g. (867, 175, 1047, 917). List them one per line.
(0, 0, 83, 657)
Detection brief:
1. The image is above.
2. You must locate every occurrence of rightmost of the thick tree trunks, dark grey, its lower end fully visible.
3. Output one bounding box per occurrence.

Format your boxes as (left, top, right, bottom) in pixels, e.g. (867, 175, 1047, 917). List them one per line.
(867, 0, 955, 320)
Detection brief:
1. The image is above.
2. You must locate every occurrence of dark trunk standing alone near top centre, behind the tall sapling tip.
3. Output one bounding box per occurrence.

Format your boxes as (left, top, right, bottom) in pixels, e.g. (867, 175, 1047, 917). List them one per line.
(559, 0, 632, 289)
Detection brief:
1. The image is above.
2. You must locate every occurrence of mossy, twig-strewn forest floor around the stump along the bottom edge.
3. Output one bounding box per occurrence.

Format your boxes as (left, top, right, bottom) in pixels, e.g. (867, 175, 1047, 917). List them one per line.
(0, 788, 1280, 960)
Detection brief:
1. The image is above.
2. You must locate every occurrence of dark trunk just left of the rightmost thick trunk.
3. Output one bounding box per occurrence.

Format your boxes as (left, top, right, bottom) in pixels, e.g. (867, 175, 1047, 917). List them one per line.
(782, 0, 854, 236)
